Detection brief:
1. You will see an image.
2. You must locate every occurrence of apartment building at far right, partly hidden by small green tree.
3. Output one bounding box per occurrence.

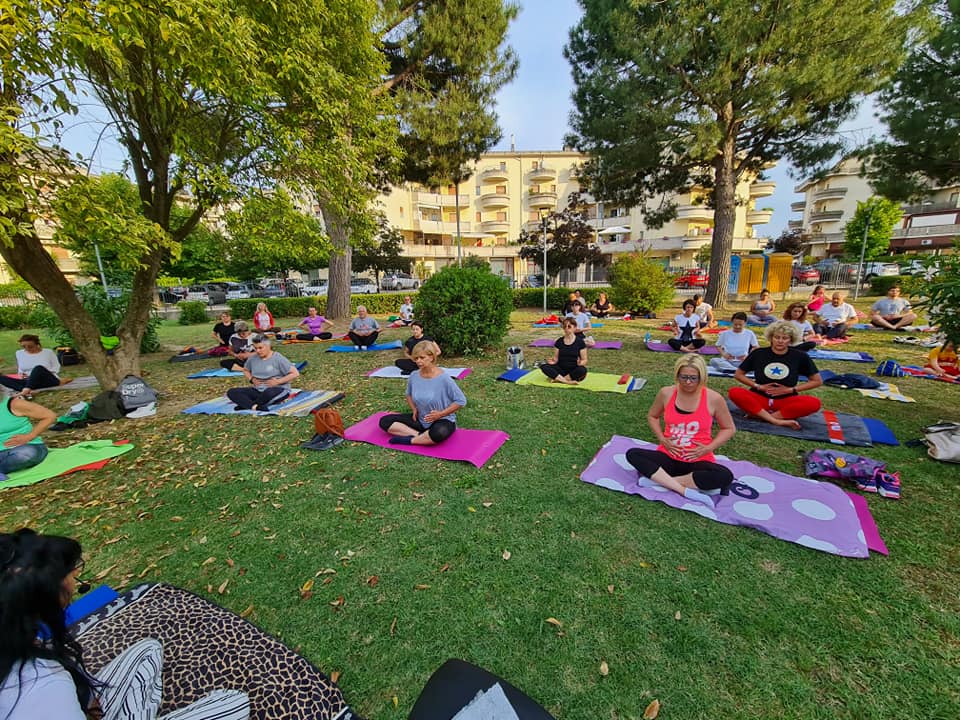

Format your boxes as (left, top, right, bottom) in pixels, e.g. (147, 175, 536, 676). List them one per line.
(790, 158, 960, 257)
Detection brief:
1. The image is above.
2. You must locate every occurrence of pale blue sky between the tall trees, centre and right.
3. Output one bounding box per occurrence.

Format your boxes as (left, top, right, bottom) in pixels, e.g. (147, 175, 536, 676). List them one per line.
(494, 0, 881, 237)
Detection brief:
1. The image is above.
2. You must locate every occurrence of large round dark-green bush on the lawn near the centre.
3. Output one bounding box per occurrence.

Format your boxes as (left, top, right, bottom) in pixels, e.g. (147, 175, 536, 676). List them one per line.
(416, 266, 512, 355)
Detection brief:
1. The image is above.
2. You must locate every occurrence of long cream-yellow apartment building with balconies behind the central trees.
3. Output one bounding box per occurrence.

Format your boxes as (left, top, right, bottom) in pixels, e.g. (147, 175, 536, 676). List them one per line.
(379, 150, 776, 283)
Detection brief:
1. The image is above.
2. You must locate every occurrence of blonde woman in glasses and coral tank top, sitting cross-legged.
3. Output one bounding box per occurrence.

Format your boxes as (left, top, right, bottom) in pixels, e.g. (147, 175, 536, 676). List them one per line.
(627, 355, 736, 508)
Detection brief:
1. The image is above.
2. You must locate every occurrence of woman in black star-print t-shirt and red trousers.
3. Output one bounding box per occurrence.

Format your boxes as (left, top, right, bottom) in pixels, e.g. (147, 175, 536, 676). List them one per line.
(730, 320, 823, 430)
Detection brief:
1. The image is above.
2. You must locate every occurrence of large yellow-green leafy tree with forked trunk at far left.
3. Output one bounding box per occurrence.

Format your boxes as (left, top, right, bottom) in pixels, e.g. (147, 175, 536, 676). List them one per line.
(0, 0, 386, 387)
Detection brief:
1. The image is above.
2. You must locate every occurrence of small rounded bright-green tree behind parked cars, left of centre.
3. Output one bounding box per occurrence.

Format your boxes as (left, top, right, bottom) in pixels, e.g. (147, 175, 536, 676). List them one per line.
(224, 189, 330, 279)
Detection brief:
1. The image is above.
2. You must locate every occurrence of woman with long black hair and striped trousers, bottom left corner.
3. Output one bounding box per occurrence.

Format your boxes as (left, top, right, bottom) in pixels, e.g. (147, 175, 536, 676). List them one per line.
(0, 528, 250, 720)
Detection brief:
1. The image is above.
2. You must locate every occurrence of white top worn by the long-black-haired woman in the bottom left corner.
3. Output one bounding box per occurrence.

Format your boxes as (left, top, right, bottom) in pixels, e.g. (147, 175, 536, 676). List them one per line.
(0, 658, 86, 720)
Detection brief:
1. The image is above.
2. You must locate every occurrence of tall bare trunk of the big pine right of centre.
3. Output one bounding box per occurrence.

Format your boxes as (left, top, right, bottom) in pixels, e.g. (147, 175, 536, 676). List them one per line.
(706, 108, 737, 310)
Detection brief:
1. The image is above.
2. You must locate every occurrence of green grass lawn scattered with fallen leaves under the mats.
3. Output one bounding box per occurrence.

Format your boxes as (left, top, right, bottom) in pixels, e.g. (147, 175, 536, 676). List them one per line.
(0, 299, 960, 720)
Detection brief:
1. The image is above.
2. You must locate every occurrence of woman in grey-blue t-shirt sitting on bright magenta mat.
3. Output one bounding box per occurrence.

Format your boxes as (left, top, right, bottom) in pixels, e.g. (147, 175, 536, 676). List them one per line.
(380, 340, 467, 445)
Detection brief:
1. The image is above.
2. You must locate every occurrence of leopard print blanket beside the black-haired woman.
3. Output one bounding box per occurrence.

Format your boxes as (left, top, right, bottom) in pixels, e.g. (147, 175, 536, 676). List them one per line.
(72, 583, 359, 720)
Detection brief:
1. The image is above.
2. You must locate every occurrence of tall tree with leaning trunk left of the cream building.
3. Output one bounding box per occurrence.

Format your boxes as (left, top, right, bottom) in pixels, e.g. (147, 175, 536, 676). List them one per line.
(321, 0, 518, 318)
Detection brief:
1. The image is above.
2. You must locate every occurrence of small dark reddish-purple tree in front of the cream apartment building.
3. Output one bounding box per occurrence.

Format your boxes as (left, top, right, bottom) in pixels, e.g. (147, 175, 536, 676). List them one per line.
(520, 193, 606, 278)
